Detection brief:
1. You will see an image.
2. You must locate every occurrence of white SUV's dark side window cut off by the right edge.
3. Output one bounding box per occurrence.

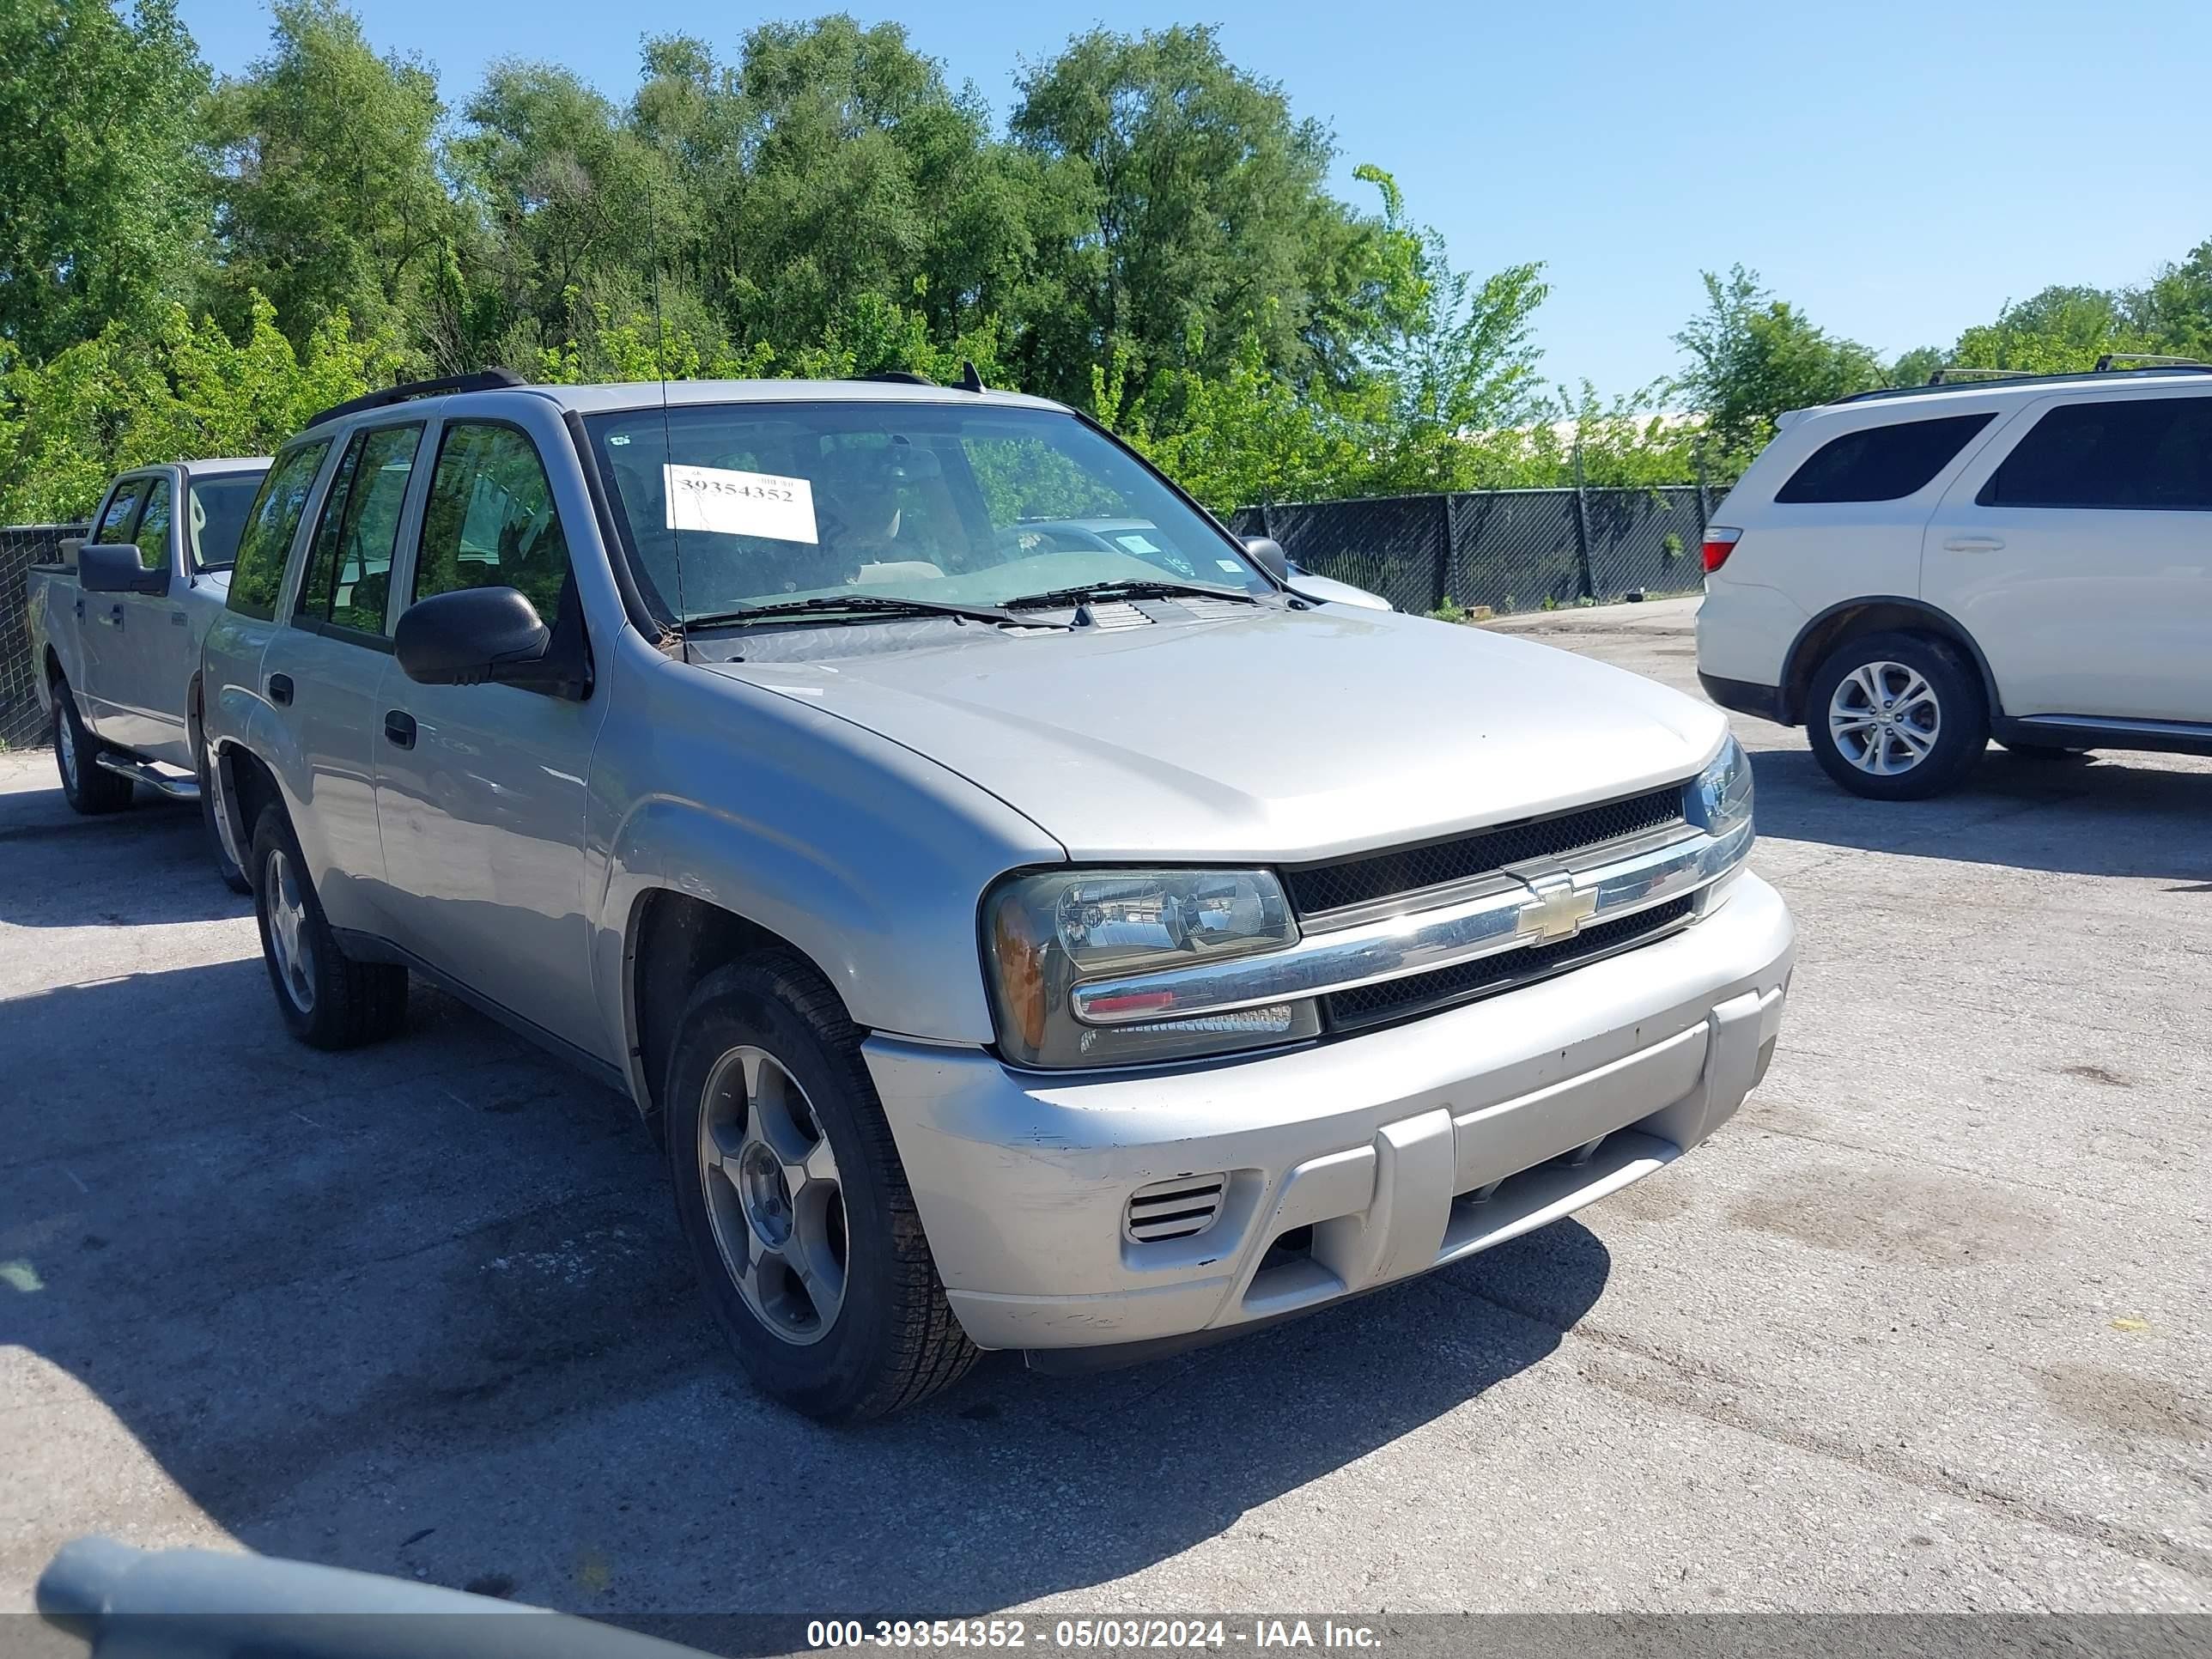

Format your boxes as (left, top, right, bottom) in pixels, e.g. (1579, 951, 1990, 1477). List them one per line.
(1980, 398, 2212, 514)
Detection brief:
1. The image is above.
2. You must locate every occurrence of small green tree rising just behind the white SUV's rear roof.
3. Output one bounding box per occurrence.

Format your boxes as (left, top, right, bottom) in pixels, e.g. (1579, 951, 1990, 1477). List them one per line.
(1674, 265, 1882, 453)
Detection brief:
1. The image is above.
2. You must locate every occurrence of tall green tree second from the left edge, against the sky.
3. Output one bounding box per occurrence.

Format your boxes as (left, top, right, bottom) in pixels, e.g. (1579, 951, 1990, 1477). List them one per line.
(208, 0, 456, 345)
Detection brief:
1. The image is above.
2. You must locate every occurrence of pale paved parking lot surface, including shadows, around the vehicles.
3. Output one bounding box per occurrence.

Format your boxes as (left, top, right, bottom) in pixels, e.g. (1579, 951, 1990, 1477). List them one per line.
(0, 602, 2212, 1617)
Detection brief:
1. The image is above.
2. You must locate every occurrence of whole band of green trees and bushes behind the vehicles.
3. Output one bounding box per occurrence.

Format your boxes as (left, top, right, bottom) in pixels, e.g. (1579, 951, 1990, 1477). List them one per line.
(0, 0, 2212, 539)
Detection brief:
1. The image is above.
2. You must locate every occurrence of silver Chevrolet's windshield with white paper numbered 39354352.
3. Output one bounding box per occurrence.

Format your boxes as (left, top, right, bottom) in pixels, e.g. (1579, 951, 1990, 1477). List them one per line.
(586, 403, 1272, 619)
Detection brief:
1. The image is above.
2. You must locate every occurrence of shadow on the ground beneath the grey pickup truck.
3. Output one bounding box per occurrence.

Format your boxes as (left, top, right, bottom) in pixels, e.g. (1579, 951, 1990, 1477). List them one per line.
(0, 785, 252, 927)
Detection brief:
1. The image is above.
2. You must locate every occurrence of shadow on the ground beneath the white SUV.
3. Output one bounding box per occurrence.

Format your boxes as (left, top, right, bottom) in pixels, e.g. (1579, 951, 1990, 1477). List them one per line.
(1752, 748, 2212, 891)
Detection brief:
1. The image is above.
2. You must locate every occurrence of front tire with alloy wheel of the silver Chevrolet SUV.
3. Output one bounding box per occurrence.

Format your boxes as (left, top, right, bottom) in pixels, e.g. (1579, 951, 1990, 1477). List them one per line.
(665, 951, 978, 1422)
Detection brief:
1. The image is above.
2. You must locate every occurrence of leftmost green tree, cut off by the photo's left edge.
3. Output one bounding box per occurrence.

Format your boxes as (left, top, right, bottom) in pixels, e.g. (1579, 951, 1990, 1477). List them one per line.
(0, 0, 208, 361)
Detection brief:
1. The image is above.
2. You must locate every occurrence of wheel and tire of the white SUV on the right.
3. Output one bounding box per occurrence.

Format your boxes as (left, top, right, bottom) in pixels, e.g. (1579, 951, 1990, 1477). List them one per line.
(1805, 633, 1989, 801)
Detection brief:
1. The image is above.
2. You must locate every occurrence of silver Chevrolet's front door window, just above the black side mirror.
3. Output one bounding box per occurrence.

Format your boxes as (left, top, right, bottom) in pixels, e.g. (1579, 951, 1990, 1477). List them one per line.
(414, 420, 568, 623)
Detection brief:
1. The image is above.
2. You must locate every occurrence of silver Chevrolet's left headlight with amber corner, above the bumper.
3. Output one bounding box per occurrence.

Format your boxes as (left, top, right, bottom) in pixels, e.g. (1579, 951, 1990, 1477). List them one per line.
(982, 869, 1321, 1066)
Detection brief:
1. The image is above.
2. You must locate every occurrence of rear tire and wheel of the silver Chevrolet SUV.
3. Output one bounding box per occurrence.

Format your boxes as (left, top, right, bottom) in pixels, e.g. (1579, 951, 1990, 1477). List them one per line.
(252, 805, 407, 1048)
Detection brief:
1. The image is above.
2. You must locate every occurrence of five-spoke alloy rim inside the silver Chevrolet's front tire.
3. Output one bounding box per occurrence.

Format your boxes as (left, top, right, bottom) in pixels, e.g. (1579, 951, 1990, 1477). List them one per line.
(699, 1048, 849, 1347)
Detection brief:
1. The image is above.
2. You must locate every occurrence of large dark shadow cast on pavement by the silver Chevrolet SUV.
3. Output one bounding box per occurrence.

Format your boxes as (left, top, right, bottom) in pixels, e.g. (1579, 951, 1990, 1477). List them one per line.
(0, 957, 1610, 1648)
